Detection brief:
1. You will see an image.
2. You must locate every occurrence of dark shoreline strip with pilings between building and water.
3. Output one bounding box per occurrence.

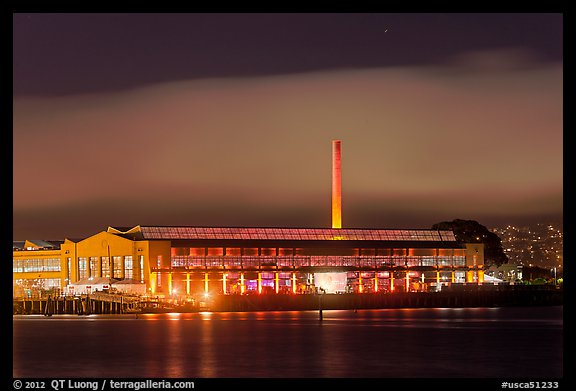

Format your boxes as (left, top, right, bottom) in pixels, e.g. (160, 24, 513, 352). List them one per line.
(12, 285, 564, 316)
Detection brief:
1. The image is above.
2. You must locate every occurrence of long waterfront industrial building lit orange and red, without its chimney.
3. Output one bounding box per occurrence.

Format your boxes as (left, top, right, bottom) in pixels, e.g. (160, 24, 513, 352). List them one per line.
(13, 226, 484, 296)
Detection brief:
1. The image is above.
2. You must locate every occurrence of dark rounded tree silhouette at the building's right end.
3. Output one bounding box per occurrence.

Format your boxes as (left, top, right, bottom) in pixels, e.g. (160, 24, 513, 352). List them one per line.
(432, 219, 508, 267)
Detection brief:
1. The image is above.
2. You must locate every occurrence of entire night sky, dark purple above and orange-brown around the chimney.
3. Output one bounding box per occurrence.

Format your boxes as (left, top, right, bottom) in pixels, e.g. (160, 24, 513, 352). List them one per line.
(13, 13, 563, 240)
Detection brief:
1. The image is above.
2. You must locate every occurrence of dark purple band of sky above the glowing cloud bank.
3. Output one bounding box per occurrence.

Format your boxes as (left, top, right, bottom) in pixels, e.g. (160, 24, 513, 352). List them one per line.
(13, 13, 563, 96)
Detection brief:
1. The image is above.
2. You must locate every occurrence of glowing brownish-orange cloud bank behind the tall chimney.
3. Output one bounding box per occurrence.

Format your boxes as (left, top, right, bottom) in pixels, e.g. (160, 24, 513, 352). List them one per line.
(14, 51, 563, 239)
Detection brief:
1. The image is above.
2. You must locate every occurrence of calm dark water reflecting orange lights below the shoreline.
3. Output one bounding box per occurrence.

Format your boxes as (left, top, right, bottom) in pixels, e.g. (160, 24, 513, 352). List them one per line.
(13, 307, 563, 378)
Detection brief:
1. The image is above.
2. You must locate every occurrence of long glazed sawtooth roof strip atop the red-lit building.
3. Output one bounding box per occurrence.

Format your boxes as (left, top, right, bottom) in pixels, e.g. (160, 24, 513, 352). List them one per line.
(135, 226, 456, 243)
